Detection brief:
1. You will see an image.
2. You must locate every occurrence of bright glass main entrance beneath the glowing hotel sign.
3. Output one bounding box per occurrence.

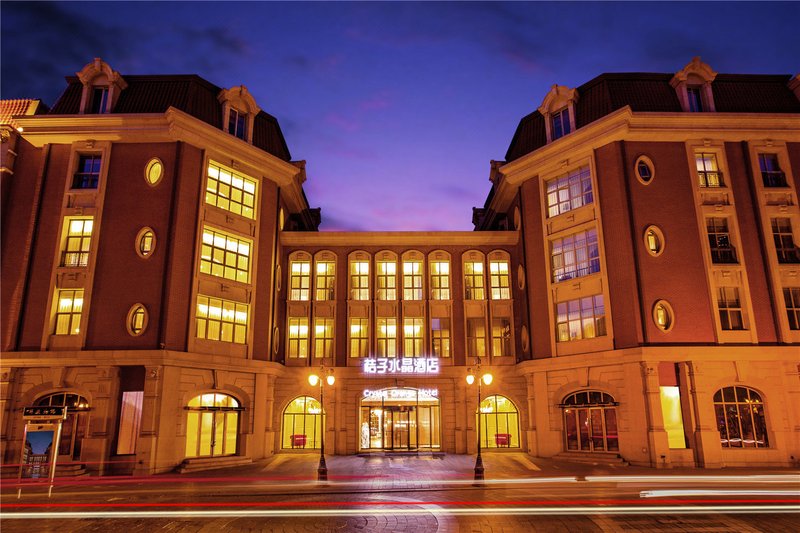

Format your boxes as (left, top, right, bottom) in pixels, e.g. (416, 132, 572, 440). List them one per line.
(358, 387, 442, 451)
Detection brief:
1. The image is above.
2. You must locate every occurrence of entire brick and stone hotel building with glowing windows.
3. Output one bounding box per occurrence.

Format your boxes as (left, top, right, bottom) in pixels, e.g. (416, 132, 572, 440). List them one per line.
(0, 58, 800, 474)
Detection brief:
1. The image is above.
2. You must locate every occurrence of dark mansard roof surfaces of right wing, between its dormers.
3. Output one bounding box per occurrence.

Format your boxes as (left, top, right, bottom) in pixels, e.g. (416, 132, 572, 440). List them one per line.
(506, 73, 800, 161)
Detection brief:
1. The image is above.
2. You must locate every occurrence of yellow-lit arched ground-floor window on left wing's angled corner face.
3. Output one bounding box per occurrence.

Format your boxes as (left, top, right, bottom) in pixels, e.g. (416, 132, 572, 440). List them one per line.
(185, 393, 242, 457)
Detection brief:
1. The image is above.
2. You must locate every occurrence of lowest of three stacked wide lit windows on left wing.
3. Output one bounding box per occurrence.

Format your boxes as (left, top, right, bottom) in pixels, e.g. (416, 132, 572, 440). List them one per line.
(196, 295, 250, 344)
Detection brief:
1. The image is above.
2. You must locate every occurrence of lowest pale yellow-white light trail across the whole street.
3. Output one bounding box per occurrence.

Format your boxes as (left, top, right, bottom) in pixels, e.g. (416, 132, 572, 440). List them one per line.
(0, 504, 800, 520)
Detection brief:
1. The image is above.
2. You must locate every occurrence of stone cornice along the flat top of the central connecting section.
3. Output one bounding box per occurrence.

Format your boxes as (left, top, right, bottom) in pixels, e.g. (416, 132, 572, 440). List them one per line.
(280, 231, 519, 248)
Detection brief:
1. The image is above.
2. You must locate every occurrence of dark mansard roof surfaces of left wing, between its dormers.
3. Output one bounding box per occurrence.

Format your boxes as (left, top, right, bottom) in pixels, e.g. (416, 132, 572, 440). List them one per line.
(50, 74, 291, 161)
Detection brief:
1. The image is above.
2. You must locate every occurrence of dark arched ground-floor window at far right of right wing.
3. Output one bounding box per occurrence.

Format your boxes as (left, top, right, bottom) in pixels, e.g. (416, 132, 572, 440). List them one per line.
(714, 387, 769, 448)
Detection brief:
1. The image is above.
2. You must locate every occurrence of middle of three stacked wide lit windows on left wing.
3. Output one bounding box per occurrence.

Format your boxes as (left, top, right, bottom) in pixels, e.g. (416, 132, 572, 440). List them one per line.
(200, 227, 253, 283)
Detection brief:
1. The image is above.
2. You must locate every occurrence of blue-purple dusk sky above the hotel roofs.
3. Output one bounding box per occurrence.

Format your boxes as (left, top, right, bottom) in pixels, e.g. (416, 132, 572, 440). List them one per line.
(0, 0, 800, 230)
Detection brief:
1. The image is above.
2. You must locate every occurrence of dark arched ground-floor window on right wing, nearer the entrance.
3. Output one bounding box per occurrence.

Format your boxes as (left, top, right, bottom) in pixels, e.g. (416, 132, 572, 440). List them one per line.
(559, 390, 619, 452)
